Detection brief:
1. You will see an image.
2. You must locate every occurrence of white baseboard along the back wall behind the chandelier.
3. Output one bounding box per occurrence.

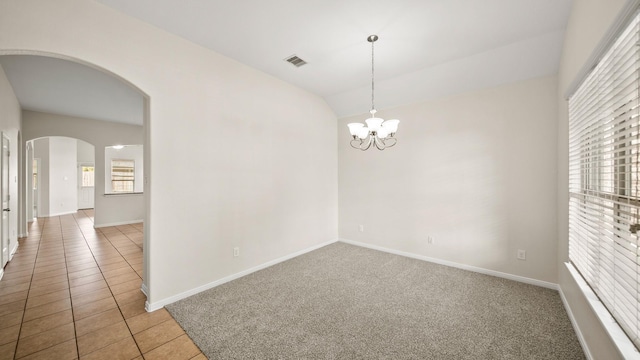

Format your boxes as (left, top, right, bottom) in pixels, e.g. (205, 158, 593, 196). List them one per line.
(340, 239, 558, 290)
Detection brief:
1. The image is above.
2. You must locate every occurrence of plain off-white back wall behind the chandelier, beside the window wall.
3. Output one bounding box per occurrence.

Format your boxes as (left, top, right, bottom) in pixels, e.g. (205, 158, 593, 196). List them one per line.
(338, 77, 557, 283)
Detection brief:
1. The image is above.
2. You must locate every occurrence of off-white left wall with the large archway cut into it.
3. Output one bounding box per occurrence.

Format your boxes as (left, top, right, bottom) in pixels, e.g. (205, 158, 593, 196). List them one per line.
(0, 0, 337, 307)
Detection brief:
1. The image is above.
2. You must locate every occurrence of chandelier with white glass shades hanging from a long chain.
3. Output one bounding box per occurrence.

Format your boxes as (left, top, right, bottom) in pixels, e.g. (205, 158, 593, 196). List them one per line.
(347, 35, 400, 151)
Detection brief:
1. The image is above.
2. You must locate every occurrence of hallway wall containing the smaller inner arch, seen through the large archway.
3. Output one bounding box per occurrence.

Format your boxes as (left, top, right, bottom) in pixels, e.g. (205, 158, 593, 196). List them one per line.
(22, 110, 145, 227)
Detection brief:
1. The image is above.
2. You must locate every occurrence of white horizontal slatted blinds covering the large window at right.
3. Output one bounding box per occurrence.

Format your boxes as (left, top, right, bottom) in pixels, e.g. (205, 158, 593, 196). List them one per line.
(569, 15, 640, 347)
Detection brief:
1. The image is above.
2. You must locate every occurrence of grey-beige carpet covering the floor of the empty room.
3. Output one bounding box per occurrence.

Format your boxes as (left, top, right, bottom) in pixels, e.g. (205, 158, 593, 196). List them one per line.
(167, 243, 585, 360)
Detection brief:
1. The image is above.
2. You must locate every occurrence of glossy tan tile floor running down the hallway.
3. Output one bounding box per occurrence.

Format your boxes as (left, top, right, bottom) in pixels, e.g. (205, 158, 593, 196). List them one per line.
(0, 210, 206, 360)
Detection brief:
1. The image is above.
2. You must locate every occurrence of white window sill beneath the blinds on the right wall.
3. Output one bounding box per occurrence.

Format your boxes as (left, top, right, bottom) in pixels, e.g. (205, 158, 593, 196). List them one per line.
(565, 262, 640, 359)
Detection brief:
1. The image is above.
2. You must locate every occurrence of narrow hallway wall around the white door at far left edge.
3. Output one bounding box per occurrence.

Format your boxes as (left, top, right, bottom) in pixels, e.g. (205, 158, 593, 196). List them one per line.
(0, 67, 23, 268)
